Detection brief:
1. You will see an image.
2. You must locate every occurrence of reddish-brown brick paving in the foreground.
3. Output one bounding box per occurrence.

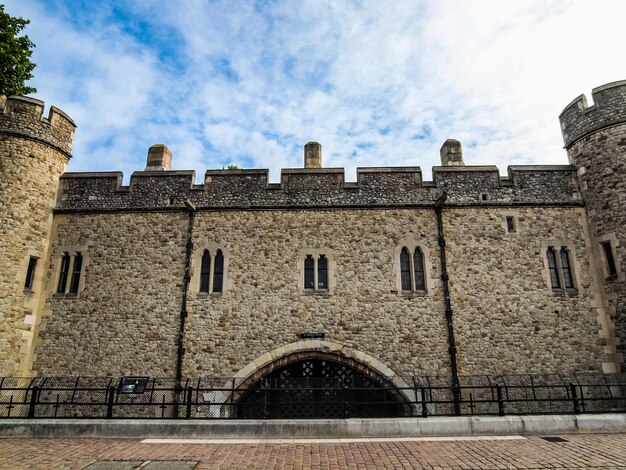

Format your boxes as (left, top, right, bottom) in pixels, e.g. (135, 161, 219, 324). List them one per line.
(0, 434, 626, 470)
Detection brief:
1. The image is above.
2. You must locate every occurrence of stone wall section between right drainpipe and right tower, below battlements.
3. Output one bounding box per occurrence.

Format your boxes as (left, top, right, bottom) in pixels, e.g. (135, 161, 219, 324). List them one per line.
(444, 207, 607, 375)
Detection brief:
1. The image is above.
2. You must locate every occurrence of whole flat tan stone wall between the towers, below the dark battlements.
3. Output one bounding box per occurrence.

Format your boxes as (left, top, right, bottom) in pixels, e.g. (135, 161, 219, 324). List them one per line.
(36, 207, 605, 377)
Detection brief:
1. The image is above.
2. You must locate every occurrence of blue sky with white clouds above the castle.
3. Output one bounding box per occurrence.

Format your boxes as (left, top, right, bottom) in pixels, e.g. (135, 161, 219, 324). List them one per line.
(3, 0, 626, 181)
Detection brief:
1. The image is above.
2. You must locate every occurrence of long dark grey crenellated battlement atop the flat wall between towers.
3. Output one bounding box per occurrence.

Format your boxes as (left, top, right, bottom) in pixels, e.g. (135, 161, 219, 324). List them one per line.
(57, 165, 581, 211)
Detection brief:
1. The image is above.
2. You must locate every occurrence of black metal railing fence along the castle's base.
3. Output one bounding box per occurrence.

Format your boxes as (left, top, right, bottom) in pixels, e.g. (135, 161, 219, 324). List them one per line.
(0, 374, 626, 419)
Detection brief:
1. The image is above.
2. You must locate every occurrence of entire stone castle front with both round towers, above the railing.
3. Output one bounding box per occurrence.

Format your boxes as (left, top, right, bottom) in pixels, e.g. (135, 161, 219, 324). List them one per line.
(0, 82, 626, 378)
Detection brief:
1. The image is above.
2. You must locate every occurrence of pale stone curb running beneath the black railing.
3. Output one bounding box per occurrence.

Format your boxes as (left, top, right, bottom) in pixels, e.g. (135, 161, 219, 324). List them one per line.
(0, 414, 626, 439)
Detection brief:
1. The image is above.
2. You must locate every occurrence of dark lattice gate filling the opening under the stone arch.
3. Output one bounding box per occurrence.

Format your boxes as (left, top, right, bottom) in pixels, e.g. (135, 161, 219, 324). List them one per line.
(237, 359, 403, 419)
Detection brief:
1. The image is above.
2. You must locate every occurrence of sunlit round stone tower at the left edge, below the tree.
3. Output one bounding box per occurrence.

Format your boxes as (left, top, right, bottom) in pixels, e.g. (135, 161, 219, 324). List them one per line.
(0, 96, 76, 376)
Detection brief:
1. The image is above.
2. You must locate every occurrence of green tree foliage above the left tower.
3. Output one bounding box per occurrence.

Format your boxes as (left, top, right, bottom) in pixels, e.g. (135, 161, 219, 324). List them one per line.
(0, 5, 37, 95)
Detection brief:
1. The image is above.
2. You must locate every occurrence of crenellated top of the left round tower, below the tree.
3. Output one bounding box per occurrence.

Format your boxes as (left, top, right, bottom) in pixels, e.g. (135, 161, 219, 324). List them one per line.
(0, 95, 76, 158)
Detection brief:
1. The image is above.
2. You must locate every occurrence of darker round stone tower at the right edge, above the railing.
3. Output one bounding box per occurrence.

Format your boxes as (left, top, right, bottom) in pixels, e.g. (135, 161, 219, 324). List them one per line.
(559, 80, 626, 372)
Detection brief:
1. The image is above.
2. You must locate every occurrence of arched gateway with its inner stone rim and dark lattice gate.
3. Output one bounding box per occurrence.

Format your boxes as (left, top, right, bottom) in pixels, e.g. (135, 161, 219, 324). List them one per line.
(234, 347, 410, 419)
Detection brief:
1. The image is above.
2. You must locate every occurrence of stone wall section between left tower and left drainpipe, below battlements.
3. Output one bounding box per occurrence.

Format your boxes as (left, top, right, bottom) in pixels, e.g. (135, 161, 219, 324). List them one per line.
(35, 213, 187, 377)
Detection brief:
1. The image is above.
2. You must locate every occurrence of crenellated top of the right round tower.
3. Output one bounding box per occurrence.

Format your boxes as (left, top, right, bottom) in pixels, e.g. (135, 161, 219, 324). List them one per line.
(559, 80, 626, 148)
